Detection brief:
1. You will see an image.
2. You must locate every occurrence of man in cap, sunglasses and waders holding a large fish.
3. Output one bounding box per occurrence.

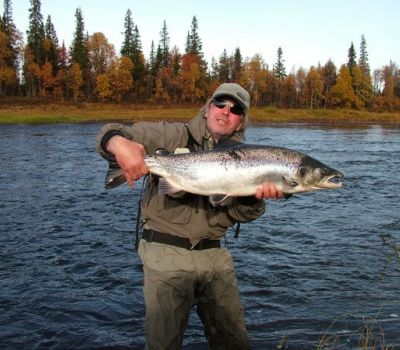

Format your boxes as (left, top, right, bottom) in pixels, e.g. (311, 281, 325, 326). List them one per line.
(97, 83, 284, 350)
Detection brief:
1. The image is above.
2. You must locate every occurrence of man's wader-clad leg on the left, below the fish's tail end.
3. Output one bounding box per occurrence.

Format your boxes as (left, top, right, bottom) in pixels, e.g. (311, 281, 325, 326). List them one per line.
(139, 242, 195, 350)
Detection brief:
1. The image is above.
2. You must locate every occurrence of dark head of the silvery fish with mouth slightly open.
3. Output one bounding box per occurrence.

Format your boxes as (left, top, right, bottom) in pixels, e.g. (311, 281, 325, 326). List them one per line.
(296, 158, 343, 192)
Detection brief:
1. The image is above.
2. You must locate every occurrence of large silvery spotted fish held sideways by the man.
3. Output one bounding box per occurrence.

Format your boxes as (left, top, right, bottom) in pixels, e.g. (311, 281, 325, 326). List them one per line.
(106, 143, 343, 204)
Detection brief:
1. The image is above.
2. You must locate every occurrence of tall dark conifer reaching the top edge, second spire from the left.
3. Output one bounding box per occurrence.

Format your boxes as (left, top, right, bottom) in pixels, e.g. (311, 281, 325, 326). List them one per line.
(27, 0, 46, 67)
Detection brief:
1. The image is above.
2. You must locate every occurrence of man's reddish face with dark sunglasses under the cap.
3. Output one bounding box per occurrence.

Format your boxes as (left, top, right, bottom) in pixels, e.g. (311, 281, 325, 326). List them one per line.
(206, 98, 244, 142)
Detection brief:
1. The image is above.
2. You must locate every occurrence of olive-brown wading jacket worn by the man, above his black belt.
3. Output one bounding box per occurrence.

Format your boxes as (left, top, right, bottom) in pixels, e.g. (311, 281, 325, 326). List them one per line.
(97, 115, 265, 245)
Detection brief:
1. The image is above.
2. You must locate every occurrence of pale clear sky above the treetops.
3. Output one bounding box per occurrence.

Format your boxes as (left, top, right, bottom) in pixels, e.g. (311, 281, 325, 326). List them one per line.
(10, 0, 400, 72)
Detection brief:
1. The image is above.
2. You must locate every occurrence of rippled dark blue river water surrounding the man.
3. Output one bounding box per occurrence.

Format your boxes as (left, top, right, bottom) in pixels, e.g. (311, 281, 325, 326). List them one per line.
(0, 124, 400, 349)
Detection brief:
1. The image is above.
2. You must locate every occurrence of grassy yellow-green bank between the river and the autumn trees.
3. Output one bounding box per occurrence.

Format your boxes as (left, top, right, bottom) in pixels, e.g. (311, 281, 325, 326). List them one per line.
(0, 103, 400, 125)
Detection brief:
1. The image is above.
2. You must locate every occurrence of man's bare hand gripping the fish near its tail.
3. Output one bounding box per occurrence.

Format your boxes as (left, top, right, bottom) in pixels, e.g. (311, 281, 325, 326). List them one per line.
(107, 136, 149, 187)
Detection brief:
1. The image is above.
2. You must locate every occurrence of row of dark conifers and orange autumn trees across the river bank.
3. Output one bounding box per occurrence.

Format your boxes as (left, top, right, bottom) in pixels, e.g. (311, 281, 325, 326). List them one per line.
(0, 0, 400, 111)
